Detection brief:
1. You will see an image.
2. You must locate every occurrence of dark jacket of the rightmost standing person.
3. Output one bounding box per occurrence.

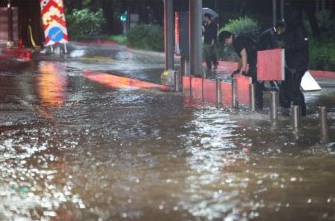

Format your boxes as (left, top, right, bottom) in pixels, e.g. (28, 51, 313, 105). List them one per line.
(285, 7, 308, 72)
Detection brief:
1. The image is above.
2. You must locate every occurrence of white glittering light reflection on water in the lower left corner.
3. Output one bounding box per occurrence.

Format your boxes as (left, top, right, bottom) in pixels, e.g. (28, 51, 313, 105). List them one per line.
(0, 127, 85, 221)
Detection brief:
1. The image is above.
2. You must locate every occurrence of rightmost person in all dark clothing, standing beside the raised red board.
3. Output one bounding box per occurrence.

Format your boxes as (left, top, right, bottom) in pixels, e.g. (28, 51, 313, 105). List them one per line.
(279, 7, 308, 116)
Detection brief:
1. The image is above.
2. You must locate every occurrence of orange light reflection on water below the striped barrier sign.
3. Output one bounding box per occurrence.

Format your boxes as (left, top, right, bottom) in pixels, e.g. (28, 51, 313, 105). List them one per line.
(38, 62, 67, 107)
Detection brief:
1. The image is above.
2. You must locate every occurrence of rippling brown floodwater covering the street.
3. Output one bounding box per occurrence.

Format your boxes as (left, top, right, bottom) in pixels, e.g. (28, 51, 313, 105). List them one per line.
(0, 43, 335, 221)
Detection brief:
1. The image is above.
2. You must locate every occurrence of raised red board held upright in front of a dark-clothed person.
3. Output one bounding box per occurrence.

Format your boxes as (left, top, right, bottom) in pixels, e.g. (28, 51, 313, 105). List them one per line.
(257, 48, 285, 81)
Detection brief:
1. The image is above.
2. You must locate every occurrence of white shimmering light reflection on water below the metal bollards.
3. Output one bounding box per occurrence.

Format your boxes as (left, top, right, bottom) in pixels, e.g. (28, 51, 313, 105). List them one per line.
(179, 108, 249, 220)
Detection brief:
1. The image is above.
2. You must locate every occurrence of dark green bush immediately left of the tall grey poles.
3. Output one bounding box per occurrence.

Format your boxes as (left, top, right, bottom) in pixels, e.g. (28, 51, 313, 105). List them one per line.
(127, 25, 164, 51)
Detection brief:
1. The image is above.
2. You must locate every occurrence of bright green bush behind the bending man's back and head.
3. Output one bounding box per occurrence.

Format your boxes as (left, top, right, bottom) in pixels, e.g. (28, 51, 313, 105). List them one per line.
(217, 16, 259, 61)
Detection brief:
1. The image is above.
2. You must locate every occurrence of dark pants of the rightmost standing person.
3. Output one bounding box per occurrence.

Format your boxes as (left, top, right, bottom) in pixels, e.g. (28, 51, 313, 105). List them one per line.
(279, 69, 306, 116)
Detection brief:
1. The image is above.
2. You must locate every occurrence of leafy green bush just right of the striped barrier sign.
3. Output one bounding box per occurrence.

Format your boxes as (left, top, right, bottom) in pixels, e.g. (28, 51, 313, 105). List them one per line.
(66, 9, 105, 40)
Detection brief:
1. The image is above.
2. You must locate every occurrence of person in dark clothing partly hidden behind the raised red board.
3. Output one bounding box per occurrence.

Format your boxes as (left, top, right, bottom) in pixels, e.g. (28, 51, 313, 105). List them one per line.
(258, 21, 286, 91)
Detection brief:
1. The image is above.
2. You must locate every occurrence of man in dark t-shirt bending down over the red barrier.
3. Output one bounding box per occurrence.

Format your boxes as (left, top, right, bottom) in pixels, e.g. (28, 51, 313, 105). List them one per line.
(219, 31, 264, 110)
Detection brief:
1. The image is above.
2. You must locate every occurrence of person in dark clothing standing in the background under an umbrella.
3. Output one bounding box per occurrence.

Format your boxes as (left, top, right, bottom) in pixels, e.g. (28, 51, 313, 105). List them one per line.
(203, 13, 218, 70)
